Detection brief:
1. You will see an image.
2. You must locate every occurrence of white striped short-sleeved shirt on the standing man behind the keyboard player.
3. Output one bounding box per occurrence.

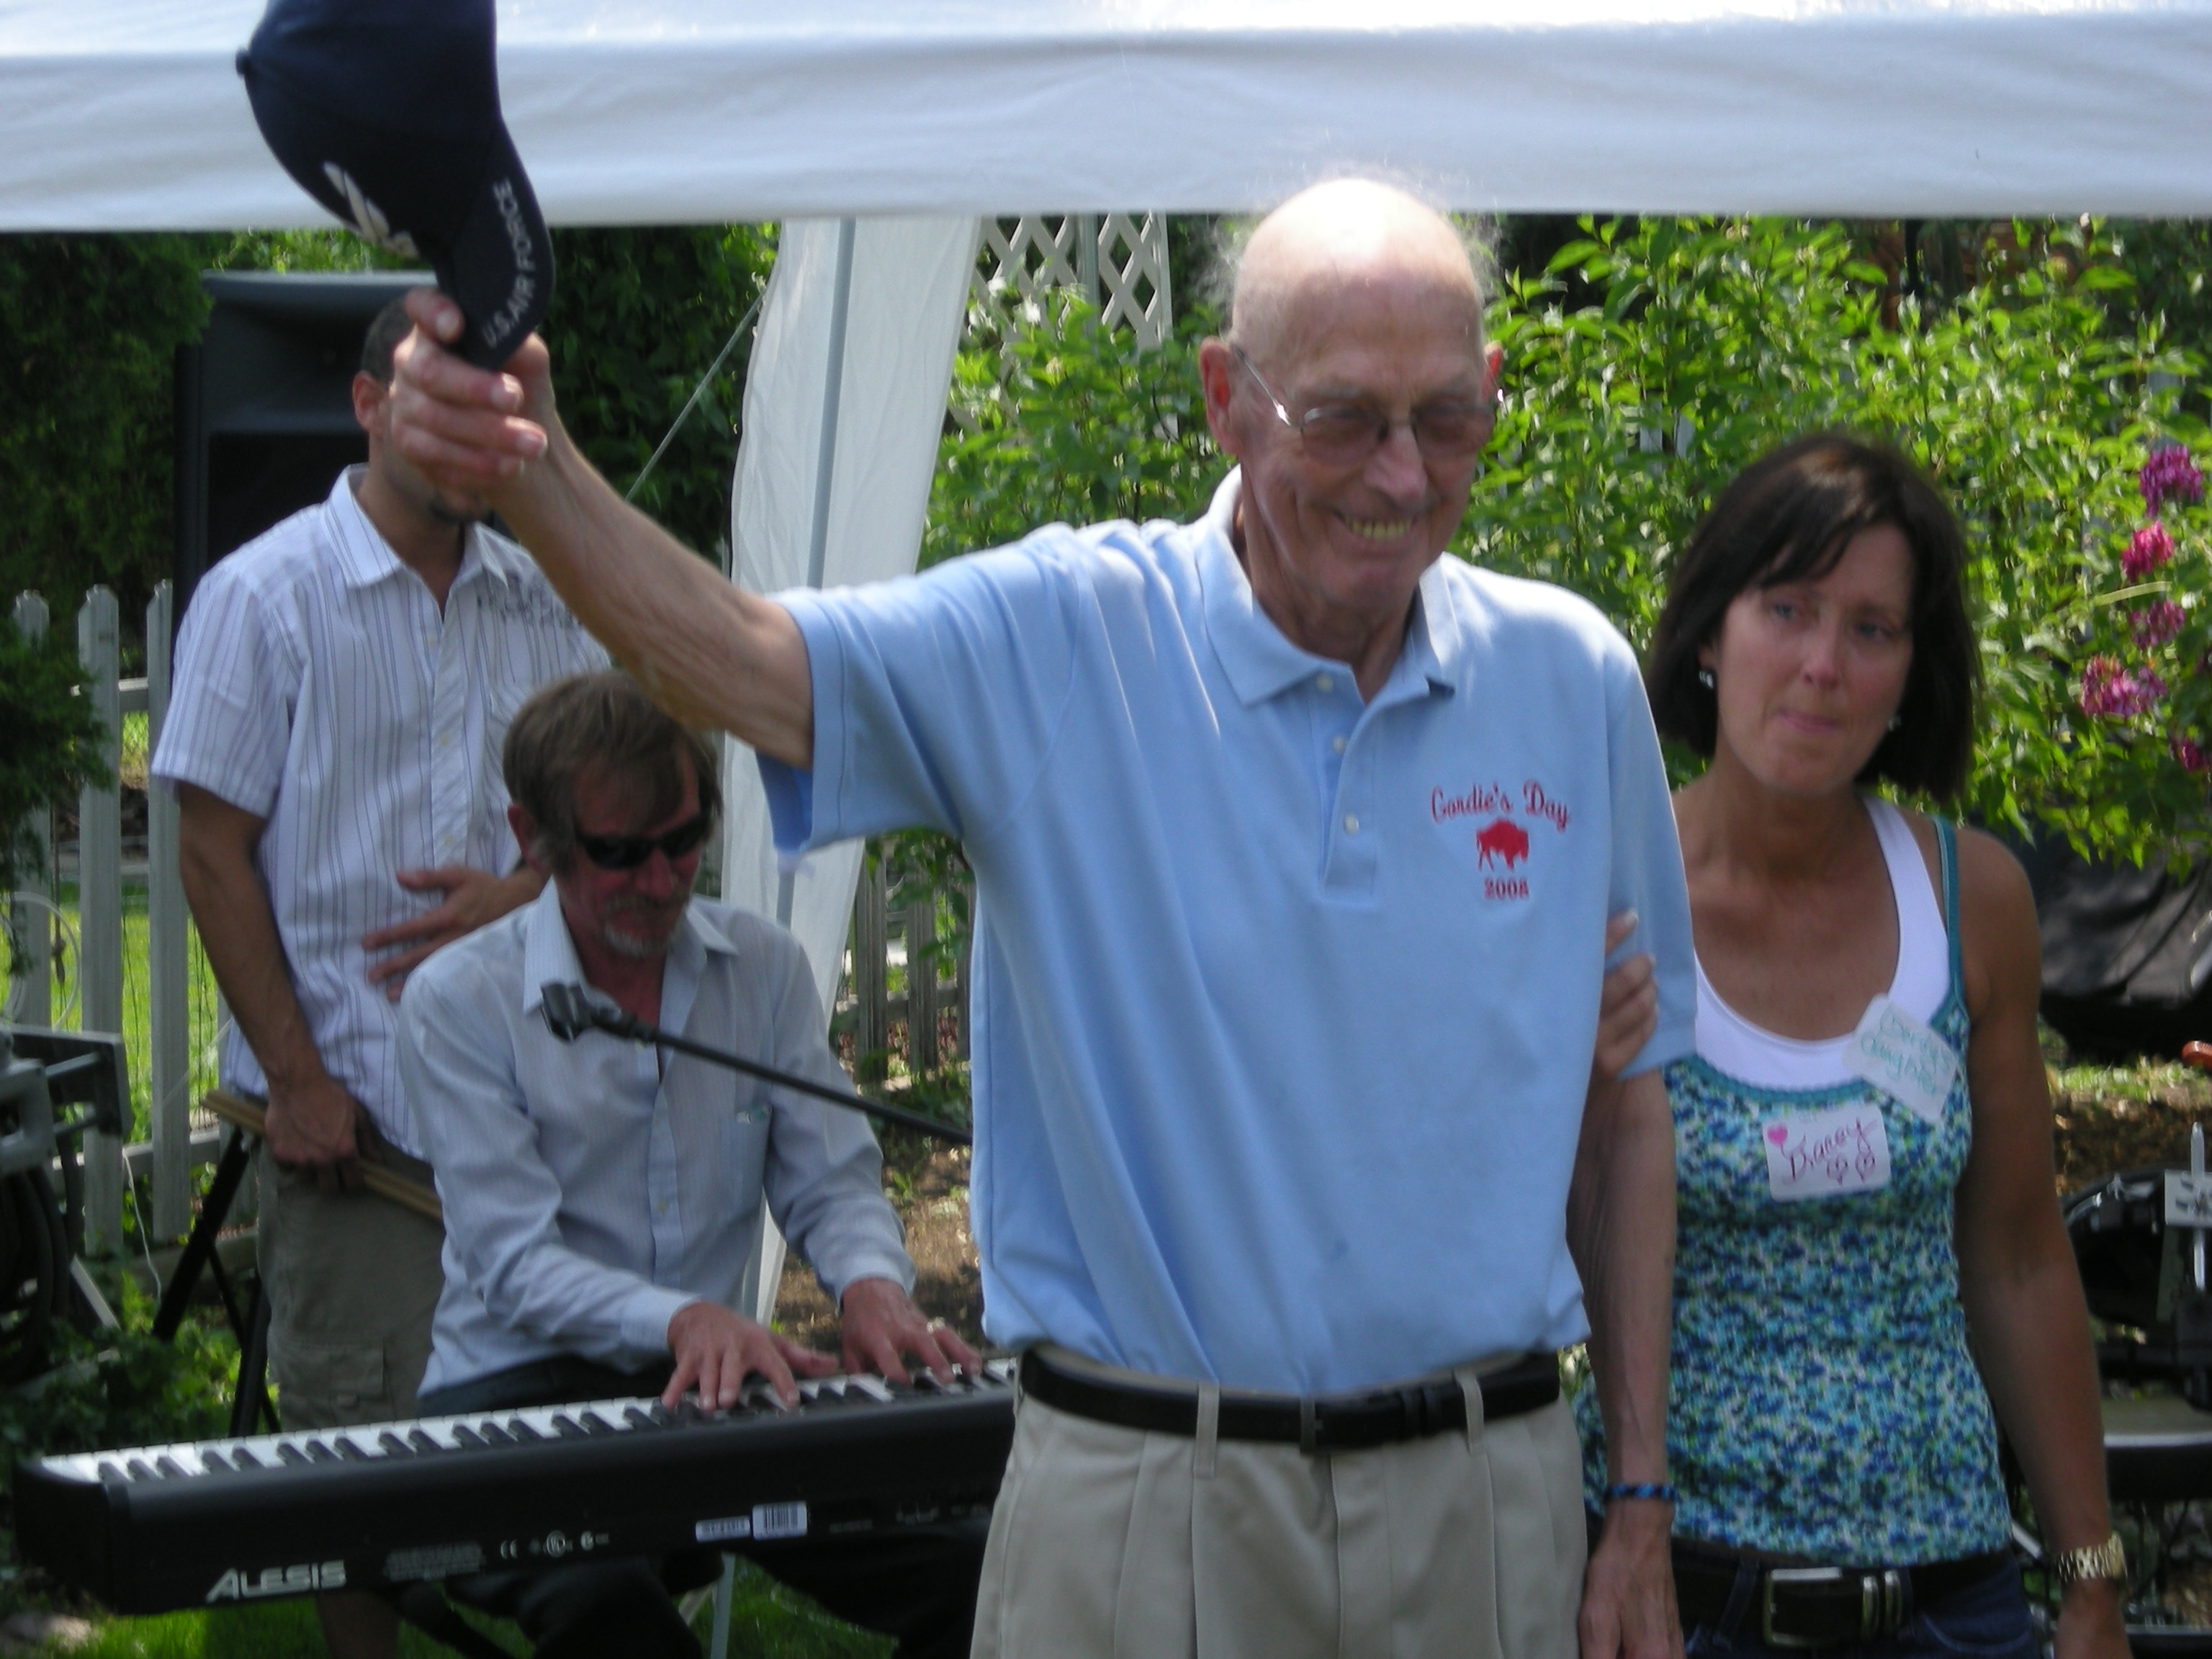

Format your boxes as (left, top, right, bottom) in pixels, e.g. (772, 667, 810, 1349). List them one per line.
(150, 467, 606, 1157)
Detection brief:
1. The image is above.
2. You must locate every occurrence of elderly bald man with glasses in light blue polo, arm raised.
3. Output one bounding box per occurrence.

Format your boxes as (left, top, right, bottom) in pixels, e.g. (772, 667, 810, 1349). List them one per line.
(400, 181, 1692, 1659)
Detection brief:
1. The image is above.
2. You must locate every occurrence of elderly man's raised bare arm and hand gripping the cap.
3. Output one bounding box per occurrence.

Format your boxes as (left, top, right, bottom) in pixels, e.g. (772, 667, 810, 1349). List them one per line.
(392, 287, 814, 768)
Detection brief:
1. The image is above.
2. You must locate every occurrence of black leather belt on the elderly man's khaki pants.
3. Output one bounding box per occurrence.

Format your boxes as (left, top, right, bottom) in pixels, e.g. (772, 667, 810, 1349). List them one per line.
(1022, 1349, 1560, 1451)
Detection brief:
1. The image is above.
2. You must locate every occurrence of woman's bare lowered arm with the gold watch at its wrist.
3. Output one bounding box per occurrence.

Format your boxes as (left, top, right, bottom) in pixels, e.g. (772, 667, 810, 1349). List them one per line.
(1956, 832, 2128, 1659)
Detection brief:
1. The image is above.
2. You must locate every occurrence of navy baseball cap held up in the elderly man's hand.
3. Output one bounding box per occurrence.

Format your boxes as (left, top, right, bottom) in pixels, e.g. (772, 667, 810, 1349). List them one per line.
(239, 0, 553, 367)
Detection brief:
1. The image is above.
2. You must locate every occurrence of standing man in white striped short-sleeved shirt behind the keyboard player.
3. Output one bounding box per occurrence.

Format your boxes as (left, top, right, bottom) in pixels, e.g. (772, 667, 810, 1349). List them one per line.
(153, 303, 606, 1659)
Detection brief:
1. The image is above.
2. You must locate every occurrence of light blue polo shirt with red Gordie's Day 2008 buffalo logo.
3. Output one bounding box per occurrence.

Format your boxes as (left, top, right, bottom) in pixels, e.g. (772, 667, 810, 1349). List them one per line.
(761, 473, 1694, 1393)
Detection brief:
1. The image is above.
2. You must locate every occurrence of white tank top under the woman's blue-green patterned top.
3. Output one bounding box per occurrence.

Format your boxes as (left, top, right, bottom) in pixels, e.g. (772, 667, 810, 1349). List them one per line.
(1696, 796, 1951, 1088)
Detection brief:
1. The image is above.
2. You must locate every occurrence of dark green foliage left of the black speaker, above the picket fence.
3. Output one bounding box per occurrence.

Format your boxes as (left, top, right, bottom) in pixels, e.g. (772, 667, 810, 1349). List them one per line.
(0, 233, 210, 617)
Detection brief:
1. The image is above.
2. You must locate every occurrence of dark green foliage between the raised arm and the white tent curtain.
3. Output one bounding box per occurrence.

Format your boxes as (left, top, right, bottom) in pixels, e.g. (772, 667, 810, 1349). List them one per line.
(542, 225, 776, 562)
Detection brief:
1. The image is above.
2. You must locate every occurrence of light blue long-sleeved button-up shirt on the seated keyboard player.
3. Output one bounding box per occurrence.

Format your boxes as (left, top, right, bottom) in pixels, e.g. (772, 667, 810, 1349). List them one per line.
(400, 885, 914, 1391)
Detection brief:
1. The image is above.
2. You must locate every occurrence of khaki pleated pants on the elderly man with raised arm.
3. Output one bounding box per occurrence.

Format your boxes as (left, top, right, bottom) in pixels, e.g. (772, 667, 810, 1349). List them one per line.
(974, 1367, 1586, 1659)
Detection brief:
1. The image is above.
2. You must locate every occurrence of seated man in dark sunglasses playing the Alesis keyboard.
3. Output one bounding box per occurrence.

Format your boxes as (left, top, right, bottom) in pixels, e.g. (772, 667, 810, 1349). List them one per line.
(400, 673, 984, 1659)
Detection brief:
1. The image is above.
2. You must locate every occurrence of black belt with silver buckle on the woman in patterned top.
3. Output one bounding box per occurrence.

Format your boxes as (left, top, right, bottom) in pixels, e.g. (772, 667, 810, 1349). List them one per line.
(1675, 1542, 2010, 1648)
